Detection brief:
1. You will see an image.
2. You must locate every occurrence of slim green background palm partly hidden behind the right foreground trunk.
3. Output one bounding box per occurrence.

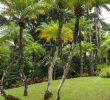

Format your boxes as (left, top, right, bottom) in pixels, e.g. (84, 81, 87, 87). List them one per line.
(67, 17, 91, 76)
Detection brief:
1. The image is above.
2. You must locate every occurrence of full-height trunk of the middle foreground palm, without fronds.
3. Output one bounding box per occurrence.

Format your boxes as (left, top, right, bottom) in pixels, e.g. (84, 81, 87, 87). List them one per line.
(44, 0, 64, 100)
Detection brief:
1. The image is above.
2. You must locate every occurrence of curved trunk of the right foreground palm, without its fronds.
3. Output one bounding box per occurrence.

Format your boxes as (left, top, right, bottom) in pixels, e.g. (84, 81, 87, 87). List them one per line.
(56, 4, 82, 100)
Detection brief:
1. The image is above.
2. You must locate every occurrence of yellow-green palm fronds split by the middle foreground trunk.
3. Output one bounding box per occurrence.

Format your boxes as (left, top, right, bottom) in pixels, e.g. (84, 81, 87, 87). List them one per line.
(40, 21, 73, 43)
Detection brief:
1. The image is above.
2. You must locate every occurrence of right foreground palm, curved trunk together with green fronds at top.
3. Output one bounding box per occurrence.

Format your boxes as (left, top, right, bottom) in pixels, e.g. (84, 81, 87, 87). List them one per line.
(56, 0, 91, 100)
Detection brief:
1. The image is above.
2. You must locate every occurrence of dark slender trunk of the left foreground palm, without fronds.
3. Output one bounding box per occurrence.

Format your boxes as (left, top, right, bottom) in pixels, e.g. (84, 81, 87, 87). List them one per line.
(19, 21, 28, 96)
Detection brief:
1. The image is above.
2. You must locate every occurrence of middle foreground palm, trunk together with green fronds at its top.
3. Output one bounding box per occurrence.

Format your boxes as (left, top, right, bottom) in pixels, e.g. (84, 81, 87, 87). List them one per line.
(40, 0, 65, 99)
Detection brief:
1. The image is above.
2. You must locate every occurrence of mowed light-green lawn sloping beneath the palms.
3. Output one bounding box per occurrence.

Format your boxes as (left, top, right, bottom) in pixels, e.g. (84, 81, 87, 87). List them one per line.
(0, 77, 110, 100)
